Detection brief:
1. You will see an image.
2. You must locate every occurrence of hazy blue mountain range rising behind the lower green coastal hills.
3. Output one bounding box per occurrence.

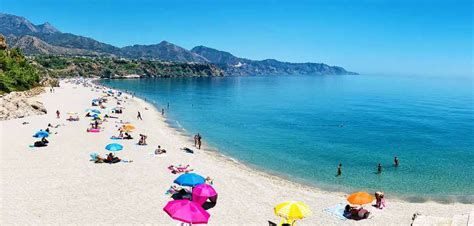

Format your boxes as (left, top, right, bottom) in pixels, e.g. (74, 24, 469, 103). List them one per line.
(0, 13, 356, 75)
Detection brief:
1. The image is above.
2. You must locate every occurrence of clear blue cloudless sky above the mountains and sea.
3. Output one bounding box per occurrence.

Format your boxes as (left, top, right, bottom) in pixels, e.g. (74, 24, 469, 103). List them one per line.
(0, 0, 474, 77)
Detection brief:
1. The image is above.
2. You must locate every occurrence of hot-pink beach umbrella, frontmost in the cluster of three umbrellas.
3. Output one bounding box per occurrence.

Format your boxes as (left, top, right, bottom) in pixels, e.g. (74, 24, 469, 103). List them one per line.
(163, 199, 211, 224)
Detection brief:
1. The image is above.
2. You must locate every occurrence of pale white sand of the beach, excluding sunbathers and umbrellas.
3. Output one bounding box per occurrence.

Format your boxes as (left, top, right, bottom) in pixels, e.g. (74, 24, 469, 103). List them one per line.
(0, 83, 474, 225)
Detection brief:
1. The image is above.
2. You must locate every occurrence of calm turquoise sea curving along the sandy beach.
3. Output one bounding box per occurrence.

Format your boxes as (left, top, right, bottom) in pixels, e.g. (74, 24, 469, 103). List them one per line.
(103, 75, 474, 202)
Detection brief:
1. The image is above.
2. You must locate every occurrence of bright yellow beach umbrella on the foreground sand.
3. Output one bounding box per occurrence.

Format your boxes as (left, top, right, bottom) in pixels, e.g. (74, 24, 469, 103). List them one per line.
(274, 201, 311, 221)
